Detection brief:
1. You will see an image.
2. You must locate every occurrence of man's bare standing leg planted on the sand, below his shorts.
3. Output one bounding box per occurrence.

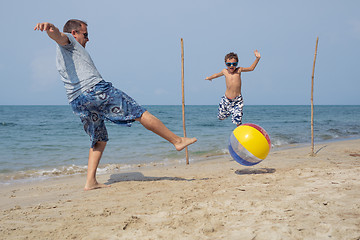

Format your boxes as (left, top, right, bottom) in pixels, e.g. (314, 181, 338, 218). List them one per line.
(84, 142, 109, 190)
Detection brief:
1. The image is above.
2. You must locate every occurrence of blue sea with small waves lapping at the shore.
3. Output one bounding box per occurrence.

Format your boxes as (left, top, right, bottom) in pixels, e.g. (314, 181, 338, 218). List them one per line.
(0, 105, 360, 185)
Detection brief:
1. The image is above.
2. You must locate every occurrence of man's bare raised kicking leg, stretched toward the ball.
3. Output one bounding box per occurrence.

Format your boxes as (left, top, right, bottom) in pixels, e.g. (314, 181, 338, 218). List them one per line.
(135, 111, 197, 151)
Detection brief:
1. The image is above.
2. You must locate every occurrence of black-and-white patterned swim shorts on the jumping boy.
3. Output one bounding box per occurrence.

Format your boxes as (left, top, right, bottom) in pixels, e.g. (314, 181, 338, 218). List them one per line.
(218, 95, 244, 125)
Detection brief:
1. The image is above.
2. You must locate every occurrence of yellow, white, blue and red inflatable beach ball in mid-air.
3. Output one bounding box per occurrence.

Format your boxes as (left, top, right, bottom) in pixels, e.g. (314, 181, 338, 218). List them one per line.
(229, 123, 271, 166)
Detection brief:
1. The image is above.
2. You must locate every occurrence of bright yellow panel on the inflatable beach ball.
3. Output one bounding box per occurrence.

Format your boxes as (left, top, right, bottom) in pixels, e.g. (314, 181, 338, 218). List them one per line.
(234, 125, 270, 160)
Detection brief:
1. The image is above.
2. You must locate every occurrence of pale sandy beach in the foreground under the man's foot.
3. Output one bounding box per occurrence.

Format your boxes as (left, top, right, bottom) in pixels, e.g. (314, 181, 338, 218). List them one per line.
(0, 140, 360, 240)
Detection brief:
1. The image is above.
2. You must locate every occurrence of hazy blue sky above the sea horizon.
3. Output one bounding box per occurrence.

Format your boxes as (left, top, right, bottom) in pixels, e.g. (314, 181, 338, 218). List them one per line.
(0, 0, 360, 105)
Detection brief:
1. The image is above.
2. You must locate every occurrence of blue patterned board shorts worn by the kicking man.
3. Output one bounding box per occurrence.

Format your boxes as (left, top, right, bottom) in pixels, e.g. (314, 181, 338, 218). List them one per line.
(70, 81, 146, 148)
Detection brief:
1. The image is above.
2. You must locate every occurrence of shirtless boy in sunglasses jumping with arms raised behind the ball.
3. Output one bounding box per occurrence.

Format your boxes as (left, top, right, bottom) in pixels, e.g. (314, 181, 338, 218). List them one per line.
(205, 50, 260, 126)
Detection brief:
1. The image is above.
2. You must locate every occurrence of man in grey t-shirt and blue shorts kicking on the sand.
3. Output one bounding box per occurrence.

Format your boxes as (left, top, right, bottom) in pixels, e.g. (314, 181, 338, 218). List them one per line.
(34, 19, 197, 190)
